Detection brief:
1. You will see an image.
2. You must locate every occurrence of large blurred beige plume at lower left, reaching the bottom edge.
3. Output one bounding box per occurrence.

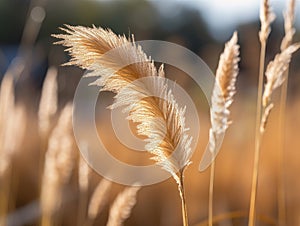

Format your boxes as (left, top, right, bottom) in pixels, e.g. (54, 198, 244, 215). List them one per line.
(40, 104, 74, 226)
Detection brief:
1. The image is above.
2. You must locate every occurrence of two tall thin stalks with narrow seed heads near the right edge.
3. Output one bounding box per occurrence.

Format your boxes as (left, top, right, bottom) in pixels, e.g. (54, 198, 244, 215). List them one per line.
(248, 0, 299, 226)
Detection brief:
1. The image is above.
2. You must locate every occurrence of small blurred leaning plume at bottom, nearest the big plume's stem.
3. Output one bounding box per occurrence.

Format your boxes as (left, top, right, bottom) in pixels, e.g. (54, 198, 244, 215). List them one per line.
(106, 187, 140, 226)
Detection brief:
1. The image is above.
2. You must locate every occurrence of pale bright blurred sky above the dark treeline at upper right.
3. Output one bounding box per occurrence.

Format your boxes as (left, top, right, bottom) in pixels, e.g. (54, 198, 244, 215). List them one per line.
(150, 0, 300, 40)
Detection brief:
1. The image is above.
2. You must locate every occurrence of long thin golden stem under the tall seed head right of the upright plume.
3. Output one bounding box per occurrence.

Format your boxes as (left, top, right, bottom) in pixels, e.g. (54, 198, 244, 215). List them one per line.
(248, 41, 266, 226)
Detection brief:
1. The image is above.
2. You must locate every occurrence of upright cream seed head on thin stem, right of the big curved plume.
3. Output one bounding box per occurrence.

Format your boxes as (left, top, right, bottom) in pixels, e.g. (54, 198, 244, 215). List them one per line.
(200, 32, 239, 226)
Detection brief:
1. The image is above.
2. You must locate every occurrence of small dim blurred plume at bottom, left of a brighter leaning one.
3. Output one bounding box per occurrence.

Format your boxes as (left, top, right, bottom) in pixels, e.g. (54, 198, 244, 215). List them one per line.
(88, 178, 112, 221)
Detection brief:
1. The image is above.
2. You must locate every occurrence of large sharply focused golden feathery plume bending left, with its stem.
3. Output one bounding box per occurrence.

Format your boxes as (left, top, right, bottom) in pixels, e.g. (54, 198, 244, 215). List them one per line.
(54, 25, 191, 226)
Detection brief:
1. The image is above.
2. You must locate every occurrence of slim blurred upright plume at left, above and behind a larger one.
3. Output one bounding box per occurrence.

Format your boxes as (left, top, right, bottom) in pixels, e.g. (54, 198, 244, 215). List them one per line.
(38, 67, 57, 135)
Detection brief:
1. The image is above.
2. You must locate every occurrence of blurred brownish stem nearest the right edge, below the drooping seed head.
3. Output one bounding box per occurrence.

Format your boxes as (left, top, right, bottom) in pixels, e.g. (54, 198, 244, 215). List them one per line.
(277, 70, 289, 226)
